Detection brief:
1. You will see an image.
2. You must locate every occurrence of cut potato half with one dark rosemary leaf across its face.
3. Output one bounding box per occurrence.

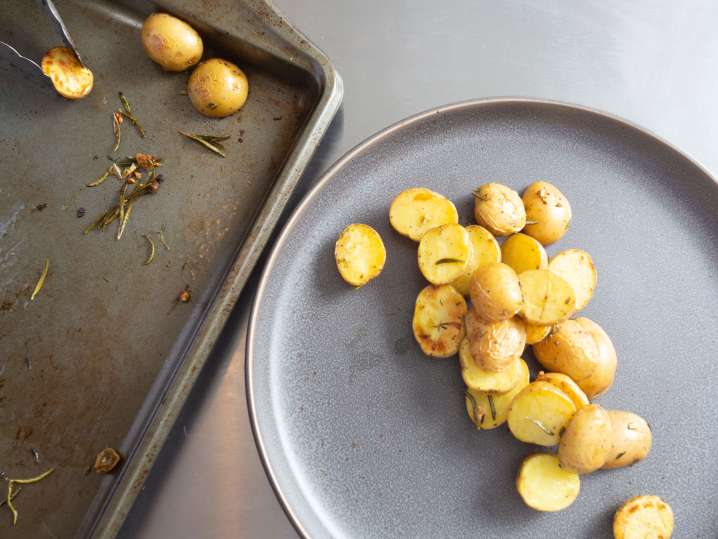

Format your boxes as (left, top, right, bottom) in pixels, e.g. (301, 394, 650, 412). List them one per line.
(418, 224, 473, 284)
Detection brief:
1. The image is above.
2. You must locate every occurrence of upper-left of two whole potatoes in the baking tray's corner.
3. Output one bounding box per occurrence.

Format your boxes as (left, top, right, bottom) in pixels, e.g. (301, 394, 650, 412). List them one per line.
(140, 13, 204, 71)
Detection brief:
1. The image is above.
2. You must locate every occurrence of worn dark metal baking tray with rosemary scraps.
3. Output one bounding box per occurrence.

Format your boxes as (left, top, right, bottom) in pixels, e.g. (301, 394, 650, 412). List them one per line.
(0, 0, 342, 538)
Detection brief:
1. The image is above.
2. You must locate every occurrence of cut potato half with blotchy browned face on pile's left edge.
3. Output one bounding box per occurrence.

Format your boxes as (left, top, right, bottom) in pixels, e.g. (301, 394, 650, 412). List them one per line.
(412, 285, 468, 357)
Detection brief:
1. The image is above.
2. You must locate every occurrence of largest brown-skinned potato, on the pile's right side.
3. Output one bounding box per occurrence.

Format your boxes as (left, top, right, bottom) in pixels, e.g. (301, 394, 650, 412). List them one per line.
(533, 318, 616, 399)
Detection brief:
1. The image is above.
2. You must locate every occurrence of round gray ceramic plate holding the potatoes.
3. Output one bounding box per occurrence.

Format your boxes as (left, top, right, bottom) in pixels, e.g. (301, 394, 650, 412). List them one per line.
(247, 99, 718, 539)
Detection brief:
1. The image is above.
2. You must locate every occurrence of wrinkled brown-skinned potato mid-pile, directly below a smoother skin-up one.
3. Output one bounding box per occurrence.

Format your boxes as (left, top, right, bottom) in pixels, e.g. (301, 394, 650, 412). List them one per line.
(465, 309, 526, 372)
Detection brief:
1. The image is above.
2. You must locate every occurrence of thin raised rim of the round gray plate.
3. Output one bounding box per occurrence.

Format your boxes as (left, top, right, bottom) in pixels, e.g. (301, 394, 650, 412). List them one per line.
(244, 97, 718, 539)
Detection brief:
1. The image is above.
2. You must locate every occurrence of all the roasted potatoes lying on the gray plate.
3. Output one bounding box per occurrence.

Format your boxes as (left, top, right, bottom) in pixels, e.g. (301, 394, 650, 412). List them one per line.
(335, 181, 673, 539)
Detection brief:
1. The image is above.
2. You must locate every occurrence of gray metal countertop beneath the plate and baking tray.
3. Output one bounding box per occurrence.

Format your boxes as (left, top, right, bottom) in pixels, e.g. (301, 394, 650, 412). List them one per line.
(121, 0, 718, 539)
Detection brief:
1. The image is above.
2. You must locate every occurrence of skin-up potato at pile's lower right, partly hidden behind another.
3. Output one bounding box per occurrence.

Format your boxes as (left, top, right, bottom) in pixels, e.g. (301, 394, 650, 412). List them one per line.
(603, 410, 653, 469)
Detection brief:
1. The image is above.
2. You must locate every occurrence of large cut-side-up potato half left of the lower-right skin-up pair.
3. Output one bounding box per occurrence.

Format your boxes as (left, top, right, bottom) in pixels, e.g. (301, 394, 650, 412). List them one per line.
(508, 382, 576, 446)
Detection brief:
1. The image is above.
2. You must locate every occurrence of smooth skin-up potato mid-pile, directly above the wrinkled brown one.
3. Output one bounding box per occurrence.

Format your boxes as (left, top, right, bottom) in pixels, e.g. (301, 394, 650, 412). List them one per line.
(470, 262, 523, 321)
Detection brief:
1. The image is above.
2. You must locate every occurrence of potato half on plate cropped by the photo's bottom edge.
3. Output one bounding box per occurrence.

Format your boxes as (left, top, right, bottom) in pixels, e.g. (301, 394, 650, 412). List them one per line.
(613, 496, 673, 539)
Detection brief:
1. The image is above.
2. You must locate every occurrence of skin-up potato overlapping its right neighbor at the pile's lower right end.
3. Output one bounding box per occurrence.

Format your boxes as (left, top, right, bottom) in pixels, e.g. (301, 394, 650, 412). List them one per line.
(558, 404, 611, 474)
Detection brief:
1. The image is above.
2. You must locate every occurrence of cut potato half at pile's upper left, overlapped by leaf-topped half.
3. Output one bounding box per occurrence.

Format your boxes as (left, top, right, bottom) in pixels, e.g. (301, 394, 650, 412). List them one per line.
(389, 187, 459, 241)
